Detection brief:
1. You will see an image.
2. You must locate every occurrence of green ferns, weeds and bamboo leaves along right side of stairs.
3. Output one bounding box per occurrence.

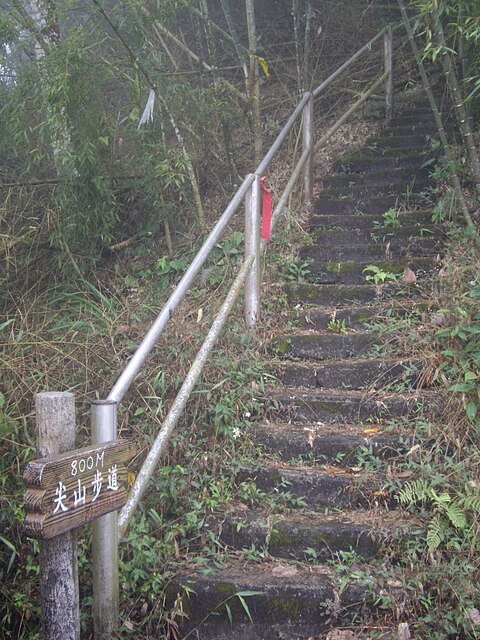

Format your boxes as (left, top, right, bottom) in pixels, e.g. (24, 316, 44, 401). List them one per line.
(348, 1, 480, 640)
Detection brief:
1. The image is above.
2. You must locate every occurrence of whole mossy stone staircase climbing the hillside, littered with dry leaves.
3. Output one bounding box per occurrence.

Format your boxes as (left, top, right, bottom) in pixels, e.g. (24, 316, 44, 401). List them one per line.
(171, 91, 443, 640)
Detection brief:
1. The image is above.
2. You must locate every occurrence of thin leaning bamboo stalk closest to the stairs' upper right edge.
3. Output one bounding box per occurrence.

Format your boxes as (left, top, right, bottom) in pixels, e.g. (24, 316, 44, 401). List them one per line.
(398, 0, 475, 230)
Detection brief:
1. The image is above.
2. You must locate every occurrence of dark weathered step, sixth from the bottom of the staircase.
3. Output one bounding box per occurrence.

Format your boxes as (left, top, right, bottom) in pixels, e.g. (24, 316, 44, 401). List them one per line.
(270, 354, 425, 389)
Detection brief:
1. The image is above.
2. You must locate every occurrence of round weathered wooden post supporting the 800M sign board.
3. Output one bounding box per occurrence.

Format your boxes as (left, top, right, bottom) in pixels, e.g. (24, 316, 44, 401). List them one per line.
(35, 392, 80, 640)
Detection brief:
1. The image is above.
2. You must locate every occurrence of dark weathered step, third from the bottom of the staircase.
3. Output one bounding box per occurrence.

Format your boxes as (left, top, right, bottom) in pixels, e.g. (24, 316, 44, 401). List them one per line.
(236, 460, 393, 510)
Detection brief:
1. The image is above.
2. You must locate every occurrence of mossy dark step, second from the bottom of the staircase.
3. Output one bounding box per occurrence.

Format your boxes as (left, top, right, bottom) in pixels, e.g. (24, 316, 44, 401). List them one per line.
(210, 505, 409, 561)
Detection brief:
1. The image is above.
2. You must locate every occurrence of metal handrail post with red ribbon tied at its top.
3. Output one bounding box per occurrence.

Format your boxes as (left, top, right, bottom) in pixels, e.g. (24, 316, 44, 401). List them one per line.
(245, 174, 261, 329)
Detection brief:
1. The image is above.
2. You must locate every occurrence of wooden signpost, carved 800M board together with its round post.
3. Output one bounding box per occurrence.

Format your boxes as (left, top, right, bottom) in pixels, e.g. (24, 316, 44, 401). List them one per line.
(24, 392, 135, 640)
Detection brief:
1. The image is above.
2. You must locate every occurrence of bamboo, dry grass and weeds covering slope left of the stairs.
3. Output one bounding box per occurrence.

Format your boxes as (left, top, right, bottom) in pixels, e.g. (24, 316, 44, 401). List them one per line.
(0, 0, 390, 638)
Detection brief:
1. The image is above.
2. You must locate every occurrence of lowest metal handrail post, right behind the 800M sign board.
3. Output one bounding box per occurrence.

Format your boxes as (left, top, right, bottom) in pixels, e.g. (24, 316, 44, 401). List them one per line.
(91, 400, 119, 640)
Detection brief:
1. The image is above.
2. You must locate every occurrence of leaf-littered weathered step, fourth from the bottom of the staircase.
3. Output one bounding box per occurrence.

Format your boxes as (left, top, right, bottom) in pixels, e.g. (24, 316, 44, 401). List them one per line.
(249, 422, 408, 466)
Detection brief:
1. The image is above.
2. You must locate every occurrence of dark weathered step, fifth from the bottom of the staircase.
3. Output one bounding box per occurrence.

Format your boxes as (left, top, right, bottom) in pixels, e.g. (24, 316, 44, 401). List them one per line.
(270, 388, 439, 423)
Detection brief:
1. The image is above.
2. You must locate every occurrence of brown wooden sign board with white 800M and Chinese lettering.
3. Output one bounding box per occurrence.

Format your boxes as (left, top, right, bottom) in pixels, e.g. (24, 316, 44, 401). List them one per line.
(23, 440, 135, 539)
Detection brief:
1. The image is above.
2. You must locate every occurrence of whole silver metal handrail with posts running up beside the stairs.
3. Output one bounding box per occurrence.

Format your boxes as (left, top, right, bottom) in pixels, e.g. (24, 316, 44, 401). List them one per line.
(92, 23, 392, 638)
